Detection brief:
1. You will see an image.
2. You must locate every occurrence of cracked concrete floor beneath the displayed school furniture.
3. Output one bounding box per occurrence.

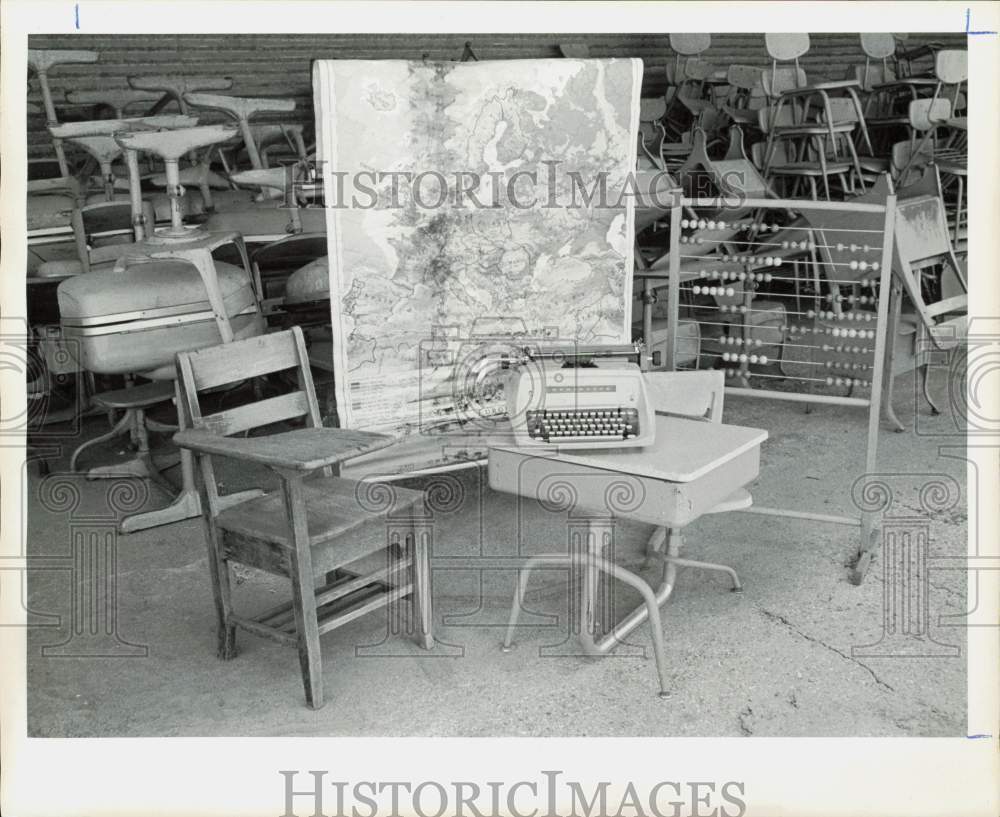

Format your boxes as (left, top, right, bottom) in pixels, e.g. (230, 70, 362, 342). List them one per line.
(27, 366, 967, 737)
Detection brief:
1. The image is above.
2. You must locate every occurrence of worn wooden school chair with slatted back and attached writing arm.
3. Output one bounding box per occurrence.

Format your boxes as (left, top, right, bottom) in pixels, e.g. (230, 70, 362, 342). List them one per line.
(174, 327, 433, 709)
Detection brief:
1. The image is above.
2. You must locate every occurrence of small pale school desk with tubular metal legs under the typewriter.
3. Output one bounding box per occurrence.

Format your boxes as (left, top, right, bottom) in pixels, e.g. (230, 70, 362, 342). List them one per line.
(489, 415, 767, 697)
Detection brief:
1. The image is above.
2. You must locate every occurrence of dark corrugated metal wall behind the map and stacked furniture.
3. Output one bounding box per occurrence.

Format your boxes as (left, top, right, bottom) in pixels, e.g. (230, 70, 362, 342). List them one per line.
(28, 33, 965, 157)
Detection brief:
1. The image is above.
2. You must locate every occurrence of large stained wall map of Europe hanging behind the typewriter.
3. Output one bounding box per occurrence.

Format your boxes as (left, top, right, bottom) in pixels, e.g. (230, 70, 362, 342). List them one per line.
(314, 59, 642, 444)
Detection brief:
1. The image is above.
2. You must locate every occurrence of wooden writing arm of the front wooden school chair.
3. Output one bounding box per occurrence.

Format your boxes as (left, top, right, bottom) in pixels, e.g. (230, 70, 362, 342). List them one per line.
(174, 428, 395, 472)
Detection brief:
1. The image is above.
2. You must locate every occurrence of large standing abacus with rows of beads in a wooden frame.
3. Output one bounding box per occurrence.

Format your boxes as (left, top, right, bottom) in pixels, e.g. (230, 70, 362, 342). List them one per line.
(644, 190, 896, 584)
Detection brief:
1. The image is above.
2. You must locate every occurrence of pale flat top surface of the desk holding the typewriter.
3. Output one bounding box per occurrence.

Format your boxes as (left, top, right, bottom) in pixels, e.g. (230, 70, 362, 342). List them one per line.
(491, 415, 767, 482)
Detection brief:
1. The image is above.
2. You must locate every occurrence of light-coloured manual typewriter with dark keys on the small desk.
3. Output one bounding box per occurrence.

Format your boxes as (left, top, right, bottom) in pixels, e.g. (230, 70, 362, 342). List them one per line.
(505, 361, 655, 449)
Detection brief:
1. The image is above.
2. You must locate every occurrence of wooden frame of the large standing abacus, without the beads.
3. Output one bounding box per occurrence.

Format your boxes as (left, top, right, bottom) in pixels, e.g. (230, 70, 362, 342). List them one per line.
(665, 193, 896, 584)
